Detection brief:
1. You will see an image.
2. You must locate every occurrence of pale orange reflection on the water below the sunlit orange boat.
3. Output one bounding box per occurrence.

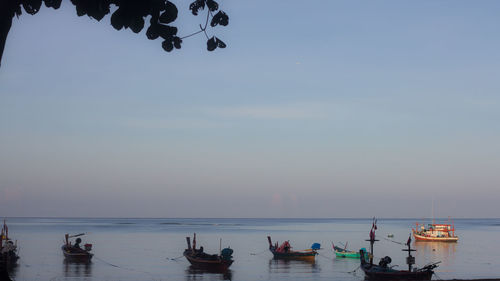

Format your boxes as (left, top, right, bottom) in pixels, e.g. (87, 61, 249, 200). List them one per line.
(415, 241, 458, 267)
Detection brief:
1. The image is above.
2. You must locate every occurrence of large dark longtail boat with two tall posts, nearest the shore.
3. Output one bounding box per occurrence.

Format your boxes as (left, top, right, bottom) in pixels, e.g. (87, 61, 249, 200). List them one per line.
(359, 219, 439, 280)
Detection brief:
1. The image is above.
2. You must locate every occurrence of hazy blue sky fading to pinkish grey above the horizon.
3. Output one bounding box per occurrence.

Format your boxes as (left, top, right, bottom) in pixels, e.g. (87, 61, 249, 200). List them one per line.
(0, 0, 500, 218)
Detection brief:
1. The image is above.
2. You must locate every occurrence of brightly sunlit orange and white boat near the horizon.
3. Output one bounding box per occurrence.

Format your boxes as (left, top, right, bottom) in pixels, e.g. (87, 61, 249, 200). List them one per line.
(412, 219, 458, 242)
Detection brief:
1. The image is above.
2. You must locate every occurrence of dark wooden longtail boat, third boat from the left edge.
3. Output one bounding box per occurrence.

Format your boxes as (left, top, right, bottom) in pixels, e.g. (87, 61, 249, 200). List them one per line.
(183, 233, 233, 271)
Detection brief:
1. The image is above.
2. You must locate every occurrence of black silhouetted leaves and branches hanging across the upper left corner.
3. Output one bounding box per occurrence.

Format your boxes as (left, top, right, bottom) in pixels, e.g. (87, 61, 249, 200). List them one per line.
(0, 0, 229, 66)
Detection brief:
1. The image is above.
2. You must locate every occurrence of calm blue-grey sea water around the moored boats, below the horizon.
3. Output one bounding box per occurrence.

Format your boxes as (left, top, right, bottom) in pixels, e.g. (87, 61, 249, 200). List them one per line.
(3, 218, 500, 281)
